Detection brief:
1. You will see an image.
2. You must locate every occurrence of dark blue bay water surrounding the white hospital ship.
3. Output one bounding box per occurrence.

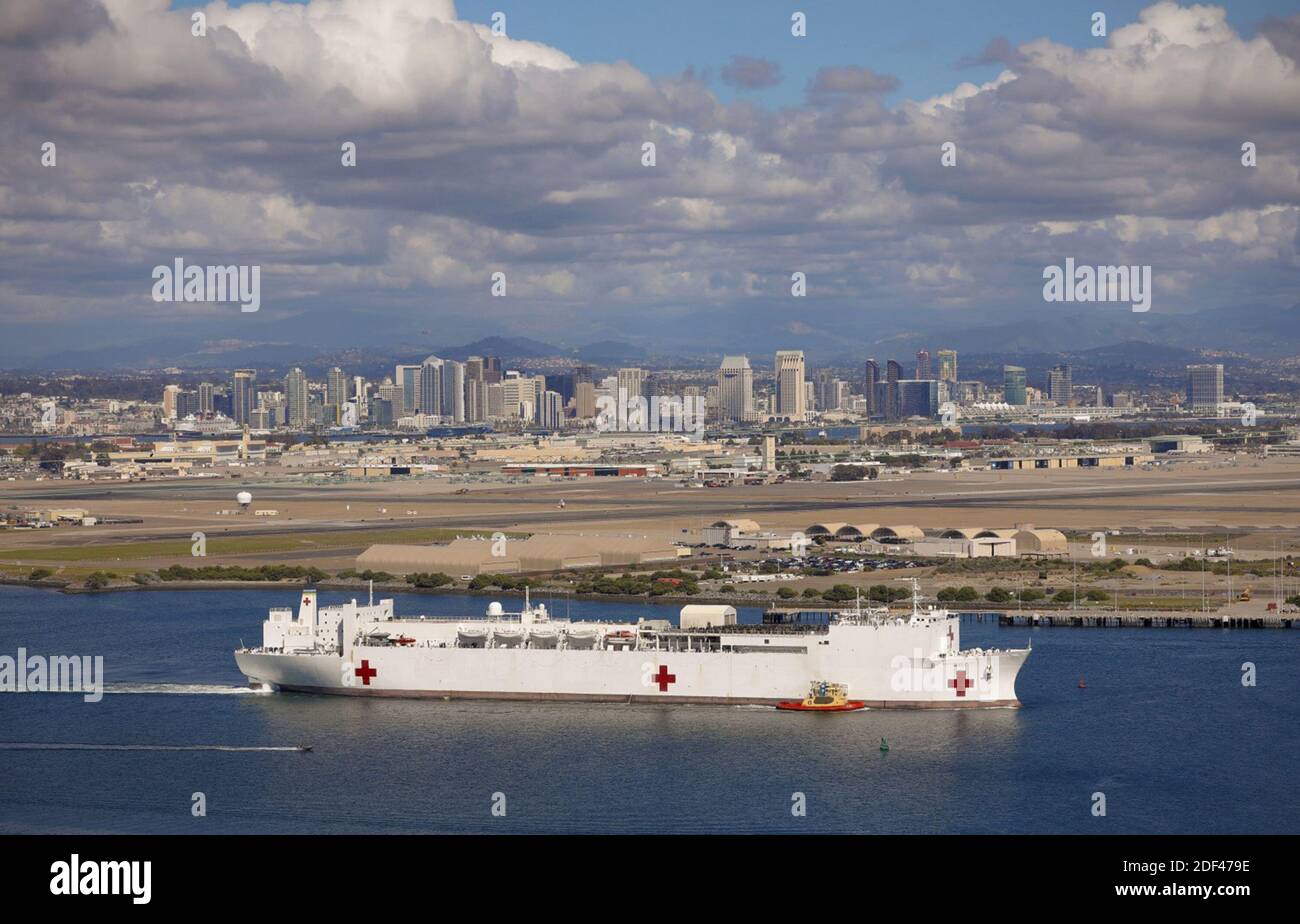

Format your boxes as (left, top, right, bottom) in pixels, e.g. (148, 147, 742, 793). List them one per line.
(0, 587, 1300, 833)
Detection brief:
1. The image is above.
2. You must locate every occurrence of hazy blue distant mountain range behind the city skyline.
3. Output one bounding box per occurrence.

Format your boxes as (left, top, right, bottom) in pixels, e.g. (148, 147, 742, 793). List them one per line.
(5, 305, 1300, 377)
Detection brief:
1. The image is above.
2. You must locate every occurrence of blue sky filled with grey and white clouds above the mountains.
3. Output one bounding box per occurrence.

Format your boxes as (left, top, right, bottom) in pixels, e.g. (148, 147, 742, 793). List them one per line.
(0, 0, 1300, 366)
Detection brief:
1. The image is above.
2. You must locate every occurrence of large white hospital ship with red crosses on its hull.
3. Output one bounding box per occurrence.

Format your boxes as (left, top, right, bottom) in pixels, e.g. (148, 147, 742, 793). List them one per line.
(235, 590, 1030, 708)
